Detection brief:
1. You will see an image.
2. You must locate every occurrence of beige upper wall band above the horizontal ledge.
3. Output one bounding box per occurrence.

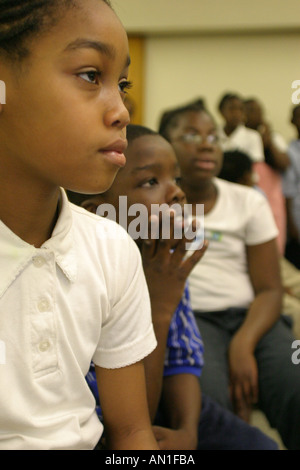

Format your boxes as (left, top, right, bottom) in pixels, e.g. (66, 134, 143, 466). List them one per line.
(112, 0, 300, 34)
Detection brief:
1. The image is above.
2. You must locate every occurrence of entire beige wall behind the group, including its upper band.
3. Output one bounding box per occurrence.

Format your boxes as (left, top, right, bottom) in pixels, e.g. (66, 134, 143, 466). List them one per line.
(113, 0, 300, 140)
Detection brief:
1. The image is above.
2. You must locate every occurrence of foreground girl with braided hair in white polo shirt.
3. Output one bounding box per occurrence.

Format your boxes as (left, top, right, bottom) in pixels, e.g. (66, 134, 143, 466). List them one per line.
(0, 0, 158, 450)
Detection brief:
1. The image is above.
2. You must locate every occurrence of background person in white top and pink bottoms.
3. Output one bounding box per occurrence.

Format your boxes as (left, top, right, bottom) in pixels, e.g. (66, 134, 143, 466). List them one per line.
(244, 98, 290, 255)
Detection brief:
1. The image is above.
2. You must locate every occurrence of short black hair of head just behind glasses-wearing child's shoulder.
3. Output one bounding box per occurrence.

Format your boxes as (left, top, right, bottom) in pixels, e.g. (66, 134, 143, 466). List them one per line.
(218, 150, 253, 183)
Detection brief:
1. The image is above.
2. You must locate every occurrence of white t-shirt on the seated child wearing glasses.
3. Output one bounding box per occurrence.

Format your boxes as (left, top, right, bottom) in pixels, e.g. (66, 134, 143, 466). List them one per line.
(189, 178, 278, 312)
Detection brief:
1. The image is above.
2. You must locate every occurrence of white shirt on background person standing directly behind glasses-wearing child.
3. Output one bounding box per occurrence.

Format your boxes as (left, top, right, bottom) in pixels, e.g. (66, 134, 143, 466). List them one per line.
(219, 124, 265, 162)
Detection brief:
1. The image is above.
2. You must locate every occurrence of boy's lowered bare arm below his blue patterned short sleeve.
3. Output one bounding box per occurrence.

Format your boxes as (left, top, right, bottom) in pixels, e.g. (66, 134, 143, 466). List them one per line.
(162, 374, 201, 445)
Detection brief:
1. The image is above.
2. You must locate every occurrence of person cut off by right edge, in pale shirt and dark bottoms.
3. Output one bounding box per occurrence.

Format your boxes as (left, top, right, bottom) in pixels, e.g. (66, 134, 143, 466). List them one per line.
(282, 105, 300, 269)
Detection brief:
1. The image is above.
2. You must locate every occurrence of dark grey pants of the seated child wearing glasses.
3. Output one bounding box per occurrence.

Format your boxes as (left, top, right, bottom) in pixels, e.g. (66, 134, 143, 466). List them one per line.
(195, 309, 300, 450)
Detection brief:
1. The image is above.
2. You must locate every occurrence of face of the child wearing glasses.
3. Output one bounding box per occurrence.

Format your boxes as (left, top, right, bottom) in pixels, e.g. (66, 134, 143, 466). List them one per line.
(169, 111, 222, 182)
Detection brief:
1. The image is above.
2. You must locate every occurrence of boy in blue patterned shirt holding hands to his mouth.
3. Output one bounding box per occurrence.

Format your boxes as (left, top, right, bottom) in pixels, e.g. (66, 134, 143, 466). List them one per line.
(69, 125, 277, 450)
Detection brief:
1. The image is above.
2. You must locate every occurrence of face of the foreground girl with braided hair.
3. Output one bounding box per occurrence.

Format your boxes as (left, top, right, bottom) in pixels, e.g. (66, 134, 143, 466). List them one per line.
(0, 0, 129, 193)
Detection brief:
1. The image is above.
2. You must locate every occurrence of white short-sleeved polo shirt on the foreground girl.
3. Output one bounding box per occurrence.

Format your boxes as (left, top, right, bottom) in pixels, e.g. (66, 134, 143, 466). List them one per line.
(0, 192, 156, 450)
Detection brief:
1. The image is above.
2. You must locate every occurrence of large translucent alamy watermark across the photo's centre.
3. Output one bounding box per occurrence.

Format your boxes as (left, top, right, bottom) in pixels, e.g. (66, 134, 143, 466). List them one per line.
(97, 196, 204, 250)
